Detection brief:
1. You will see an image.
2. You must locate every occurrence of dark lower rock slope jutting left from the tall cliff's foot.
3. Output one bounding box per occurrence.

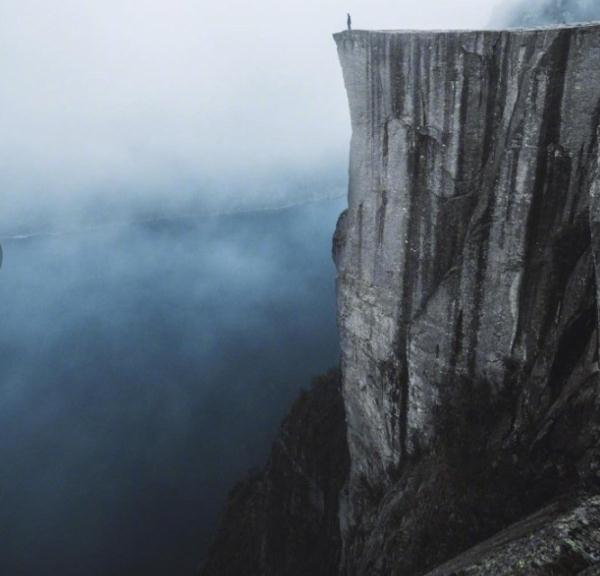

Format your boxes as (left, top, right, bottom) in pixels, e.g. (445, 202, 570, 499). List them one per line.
(201, 371, 348, 576)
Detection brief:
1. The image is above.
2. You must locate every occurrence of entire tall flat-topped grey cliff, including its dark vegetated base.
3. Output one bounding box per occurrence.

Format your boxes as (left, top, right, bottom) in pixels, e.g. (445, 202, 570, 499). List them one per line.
(200, 25, 600, 576)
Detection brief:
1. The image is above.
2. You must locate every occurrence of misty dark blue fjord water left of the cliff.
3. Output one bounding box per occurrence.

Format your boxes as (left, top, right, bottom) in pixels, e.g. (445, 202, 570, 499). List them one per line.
(0, 199, 344, 576)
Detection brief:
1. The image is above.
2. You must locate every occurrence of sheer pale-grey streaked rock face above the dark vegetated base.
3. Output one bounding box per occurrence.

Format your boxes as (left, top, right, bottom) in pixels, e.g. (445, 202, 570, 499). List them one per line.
(335, 25, 600, 512)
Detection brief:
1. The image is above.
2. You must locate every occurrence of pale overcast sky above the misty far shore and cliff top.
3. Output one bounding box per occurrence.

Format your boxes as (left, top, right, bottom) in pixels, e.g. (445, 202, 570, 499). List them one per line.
(0, 0, 506, 230)
